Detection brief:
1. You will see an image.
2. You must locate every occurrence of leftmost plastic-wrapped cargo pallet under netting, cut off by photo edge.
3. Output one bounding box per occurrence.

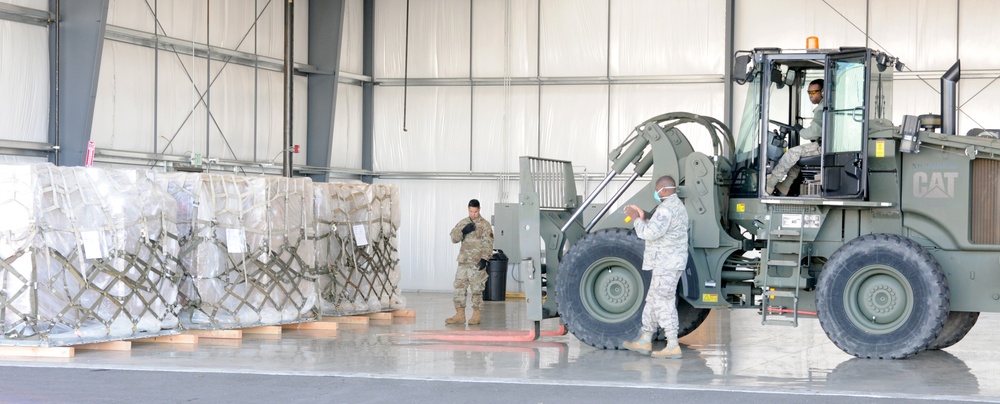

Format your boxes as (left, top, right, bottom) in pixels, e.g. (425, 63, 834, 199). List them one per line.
(0, 164, 179, 346)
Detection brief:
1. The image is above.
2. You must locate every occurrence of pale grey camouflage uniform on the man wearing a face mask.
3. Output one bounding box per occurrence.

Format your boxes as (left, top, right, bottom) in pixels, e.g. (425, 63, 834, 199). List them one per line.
(633, 194, 688, 337)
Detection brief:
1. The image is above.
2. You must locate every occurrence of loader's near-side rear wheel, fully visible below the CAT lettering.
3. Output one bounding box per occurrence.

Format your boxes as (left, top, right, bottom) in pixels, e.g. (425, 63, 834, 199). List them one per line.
(816, 234, 951, 359)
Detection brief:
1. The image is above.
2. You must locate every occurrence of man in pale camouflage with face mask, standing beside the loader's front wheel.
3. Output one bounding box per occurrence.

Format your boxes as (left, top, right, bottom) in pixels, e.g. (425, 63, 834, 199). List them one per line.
(624, 175, 688, 359)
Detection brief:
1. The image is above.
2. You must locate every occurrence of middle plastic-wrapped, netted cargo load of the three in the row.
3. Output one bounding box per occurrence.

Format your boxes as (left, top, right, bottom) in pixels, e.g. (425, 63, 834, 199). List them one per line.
(156, 173, 316, 329)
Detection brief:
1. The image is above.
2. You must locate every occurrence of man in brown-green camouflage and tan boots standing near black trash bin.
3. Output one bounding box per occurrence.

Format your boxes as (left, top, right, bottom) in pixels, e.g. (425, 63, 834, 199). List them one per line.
(444, 199, 493, 325)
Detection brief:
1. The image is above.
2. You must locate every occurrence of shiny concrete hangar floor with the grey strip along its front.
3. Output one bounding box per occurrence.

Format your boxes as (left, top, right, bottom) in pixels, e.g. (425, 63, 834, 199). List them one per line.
(0, 293, 1000, 404)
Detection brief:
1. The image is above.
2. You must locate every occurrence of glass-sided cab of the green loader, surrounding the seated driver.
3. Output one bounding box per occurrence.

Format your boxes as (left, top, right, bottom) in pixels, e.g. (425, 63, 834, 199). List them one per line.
(730, 48, 895, 200)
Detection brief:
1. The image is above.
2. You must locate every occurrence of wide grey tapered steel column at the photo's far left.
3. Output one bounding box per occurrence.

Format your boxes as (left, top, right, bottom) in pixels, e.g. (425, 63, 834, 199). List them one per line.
(49, 0, 109, 166)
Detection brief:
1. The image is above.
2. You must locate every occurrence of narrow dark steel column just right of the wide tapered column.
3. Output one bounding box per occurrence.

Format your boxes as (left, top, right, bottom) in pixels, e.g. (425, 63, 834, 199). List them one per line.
(361, 0, 375, 184)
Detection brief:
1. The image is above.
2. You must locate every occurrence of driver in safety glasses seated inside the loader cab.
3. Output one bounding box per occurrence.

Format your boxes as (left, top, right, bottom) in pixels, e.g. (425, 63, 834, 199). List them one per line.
(764, 79, 823, 195)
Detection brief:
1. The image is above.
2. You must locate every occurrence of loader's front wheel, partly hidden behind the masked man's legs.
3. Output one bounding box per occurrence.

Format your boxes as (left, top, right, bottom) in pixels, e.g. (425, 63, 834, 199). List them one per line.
(556, 229, 710, 349)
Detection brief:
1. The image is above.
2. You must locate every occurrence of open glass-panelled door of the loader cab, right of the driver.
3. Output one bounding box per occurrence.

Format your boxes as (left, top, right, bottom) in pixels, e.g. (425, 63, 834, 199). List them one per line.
(821, 49, 871, 199)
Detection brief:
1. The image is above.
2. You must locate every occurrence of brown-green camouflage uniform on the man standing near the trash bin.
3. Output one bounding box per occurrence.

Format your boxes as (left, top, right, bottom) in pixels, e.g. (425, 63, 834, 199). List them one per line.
(451, 217, 493, 309)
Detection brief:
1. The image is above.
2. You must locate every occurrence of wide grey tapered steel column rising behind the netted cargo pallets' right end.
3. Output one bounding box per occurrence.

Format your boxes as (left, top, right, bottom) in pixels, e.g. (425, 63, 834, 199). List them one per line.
(306, 0, 345, 182)
